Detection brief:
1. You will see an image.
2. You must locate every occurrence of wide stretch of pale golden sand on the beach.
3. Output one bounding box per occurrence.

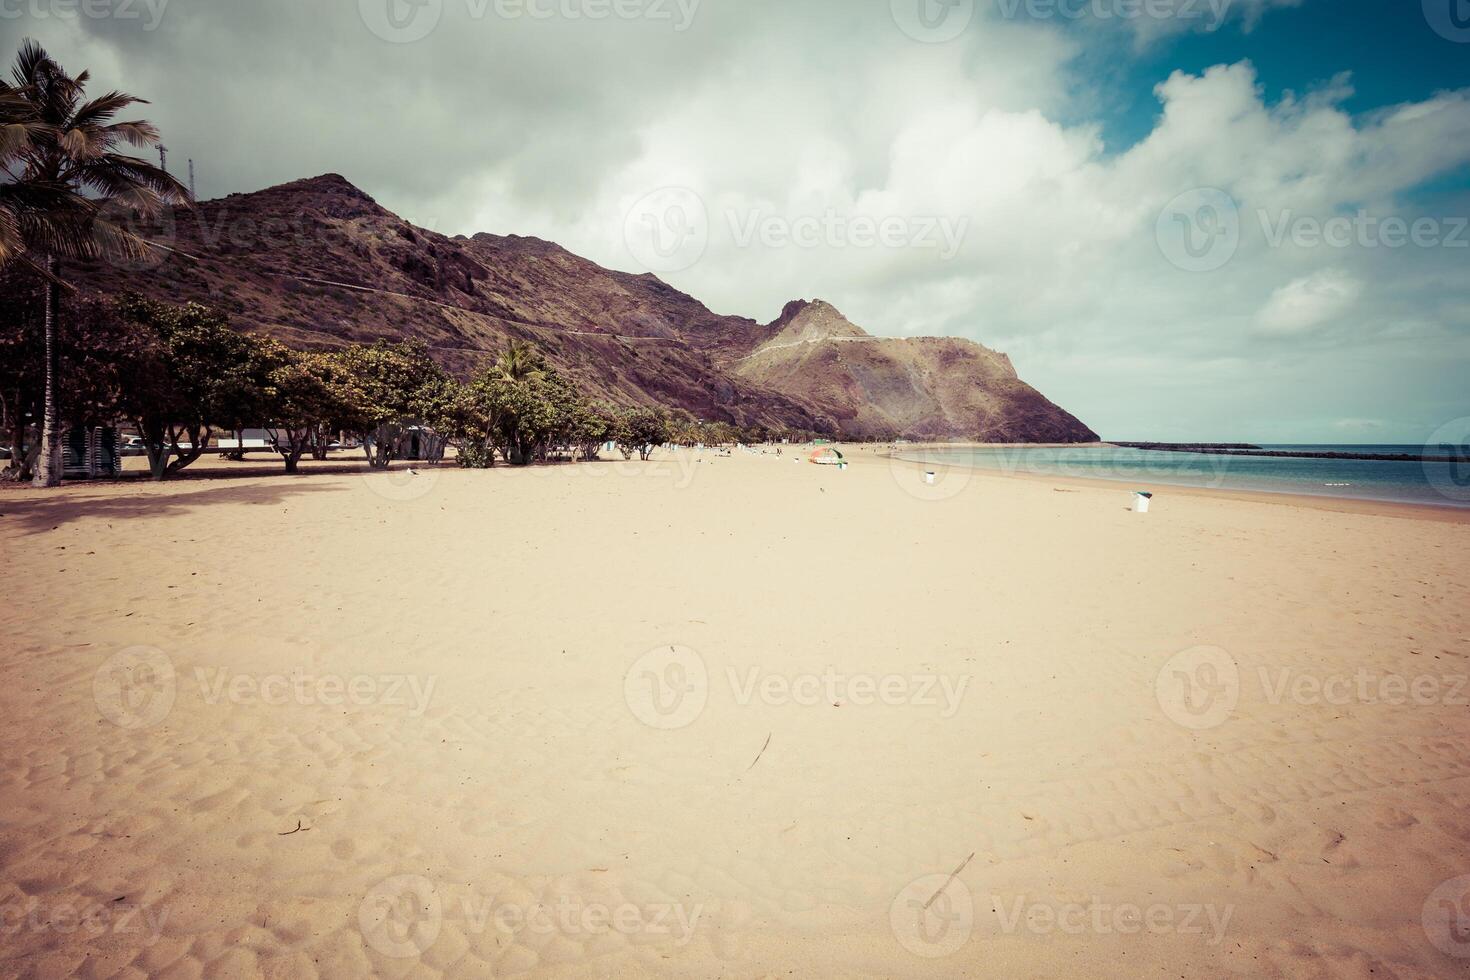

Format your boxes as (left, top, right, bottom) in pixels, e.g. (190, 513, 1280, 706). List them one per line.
(0, 451, 1470, 979)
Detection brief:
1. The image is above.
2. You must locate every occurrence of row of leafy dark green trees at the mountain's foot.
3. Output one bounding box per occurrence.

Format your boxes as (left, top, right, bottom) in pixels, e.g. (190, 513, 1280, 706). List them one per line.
(0, 279, 764, 479)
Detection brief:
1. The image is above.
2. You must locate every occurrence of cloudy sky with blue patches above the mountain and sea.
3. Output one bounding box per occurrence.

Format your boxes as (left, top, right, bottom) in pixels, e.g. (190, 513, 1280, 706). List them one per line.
(0, 0, 1470, 444)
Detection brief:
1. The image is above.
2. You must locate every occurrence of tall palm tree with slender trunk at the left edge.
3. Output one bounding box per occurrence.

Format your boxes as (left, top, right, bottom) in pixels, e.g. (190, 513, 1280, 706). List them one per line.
(0, 41, 188, 486)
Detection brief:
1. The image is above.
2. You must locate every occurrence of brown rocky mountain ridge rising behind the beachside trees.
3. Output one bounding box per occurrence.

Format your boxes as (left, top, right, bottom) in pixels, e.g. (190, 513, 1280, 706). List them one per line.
(79, 175, 1097, 442)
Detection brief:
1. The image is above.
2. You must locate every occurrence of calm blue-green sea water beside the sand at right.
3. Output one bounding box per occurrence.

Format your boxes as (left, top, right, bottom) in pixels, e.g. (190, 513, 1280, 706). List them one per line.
(900, 445, 1470, 507)
